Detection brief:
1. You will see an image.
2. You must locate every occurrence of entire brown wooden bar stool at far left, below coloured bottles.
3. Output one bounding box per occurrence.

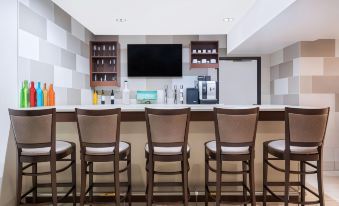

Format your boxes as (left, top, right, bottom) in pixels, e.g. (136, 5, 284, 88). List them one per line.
(9, 108, 76, 206)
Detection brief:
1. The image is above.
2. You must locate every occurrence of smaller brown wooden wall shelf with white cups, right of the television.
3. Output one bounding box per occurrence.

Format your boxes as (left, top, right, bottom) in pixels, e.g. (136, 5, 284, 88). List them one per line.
(190, 41, 219, 69)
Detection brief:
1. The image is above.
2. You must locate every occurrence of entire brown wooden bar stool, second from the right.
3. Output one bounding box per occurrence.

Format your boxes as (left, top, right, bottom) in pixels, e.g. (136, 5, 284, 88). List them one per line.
(205, 107, 259, 206)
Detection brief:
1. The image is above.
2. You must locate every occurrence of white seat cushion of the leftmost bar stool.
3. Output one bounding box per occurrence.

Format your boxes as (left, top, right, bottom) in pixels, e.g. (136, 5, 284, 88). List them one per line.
(21, 140, 72, 156)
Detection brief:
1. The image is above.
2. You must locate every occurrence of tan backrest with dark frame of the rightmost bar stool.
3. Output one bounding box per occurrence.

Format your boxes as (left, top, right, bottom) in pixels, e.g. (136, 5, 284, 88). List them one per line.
(285, 107, 329, 148)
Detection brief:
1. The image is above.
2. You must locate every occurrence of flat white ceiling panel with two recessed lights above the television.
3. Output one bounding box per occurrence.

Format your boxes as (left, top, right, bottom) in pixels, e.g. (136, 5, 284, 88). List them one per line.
(52, 0, 256, 35)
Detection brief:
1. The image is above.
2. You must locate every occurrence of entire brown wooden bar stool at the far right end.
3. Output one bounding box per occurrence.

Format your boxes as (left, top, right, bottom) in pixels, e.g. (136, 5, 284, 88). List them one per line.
(263, 107, 329, 206)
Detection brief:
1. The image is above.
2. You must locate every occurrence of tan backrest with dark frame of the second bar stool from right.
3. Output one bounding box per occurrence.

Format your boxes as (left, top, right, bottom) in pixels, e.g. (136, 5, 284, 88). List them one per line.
(214, 107, 259, 147)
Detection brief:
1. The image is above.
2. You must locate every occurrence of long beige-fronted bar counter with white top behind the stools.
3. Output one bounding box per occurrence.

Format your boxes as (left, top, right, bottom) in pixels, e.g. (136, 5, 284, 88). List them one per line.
(4, 104, 294, 204)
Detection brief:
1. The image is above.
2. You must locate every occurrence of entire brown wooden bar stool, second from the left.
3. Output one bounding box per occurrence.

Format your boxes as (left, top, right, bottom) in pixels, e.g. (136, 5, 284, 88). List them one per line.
(75, 108, 132, 205)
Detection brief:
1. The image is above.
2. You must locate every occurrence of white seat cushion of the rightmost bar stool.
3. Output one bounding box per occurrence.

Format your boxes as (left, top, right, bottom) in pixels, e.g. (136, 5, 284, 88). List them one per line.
(268, 140, 318, 154)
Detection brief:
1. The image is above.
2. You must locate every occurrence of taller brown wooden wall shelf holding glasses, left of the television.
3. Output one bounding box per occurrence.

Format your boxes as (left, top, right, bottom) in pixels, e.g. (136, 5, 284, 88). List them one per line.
(90, 41, 120, 87)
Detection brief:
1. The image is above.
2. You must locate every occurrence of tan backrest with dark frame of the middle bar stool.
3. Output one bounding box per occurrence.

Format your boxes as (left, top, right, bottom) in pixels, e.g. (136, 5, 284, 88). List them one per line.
(145, 108, 190, 151)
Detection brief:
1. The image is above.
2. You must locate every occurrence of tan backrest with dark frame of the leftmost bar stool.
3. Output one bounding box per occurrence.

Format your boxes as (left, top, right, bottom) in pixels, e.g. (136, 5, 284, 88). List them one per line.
(9, 108, 56, 150)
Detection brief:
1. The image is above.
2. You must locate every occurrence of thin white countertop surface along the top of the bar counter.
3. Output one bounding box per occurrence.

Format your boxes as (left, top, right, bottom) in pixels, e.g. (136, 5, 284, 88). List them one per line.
(38, 104, 286, 112)
